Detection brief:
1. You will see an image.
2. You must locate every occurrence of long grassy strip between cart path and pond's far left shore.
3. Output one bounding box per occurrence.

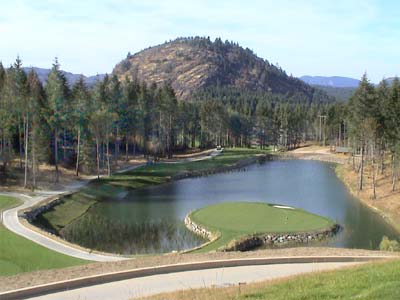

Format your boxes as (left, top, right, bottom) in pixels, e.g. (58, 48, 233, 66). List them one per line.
(37, 148, 268, 233)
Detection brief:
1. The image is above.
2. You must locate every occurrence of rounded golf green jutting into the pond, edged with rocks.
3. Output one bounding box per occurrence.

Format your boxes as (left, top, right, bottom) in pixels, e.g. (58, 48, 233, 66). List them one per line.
(189, 202, 334, 252)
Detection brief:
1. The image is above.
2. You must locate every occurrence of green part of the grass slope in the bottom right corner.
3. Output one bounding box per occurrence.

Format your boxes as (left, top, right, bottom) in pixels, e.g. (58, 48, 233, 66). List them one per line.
(238, 260, 400, 300)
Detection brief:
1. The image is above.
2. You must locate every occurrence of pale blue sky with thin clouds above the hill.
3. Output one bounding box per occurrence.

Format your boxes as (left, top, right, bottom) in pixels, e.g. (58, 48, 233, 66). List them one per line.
(0, 0, 400, 82)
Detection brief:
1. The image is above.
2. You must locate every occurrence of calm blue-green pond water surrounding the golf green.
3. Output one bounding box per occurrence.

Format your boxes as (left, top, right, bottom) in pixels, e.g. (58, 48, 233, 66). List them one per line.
(64, 160, 398, 253)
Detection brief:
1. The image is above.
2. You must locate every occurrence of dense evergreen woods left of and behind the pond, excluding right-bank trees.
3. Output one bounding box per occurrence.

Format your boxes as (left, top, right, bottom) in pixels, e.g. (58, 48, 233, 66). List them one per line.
(0, 58, 332, 187)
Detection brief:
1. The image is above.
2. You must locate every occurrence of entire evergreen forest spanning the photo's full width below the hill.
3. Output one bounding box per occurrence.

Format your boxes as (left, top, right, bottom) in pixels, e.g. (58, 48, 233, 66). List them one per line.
(0, 58, 400, 195)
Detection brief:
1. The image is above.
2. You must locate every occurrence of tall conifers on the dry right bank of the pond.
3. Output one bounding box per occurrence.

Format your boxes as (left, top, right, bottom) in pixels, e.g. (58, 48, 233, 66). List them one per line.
(324, 74, 400, 199)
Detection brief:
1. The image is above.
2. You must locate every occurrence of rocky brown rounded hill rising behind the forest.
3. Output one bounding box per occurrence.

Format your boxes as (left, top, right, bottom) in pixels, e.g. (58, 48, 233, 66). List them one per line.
(113, 37, 329, 101)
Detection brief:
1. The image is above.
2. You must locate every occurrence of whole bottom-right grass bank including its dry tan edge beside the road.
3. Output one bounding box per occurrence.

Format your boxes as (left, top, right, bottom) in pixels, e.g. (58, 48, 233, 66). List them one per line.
(143, 260, 400, 300)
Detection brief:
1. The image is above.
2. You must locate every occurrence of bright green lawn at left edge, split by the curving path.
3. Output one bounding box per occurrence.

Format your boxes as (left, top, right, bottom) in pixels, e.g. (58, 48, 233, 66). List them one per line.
(0, 196, 86, 276)
